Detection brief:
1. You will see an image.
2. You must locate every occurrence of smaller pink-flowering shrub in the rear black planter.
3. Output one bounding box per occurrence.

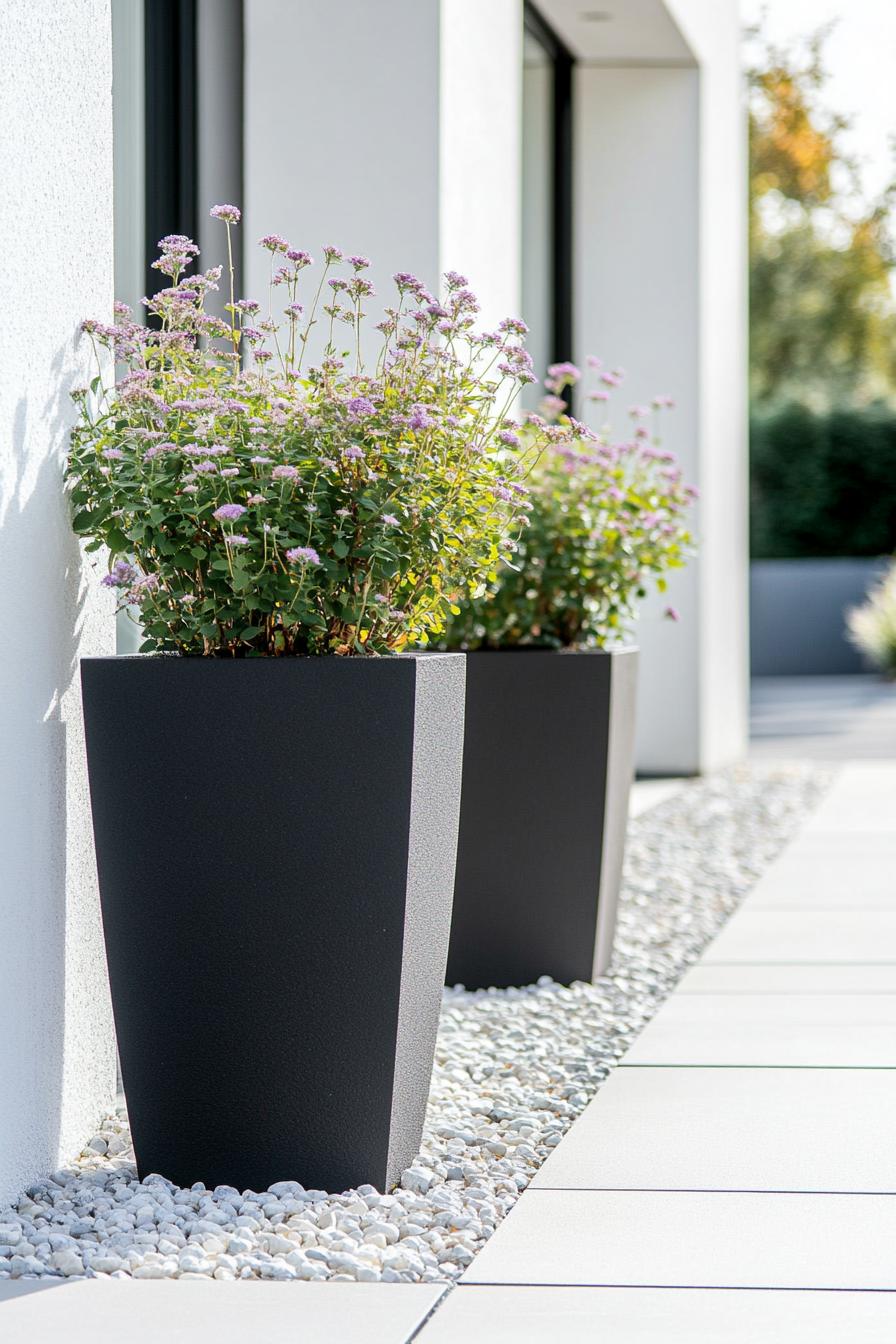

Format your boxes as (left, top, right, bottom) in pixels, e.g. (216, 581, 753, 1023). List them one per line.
(445, 359, 697, 649)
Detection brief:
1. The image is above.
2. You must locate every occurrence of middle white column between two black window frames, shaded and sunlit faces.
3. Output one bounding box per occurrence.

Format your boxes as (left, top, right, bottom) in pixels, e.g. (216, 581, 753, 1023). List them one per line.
(243, 0, 521, 352)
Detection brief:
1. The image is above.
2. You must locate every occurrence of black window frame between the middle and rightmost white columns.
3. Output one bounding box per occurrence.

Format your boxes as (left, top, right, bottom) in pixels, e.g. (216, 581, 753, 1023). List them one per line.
(523, 0, 575, 362)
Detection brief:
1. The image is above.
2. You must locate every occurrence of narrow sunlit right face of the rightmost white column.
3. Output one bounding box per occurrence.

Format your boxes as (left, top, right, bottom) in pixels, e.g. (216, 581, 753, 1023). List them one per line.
(666, 0, 750, 769)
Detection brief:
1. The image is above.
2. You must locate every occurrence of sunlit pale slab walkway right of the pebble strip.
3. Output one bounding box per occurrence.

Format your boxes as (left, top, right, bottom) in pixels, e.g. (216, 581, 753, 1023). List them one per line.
(419, 762, 896, 1344)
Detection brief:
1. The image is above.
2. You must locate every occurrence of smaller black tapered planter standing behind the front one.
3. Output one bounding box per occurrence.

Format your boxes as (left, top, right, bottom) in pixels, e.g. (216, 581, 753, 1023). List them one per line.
(447, 649, 638, 988)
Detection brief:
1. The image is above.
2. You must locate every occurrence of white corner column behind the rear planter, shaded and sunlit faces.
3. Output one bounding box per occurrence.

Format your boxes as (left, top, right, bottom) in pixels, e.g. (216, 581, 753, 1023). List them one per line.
(575, 0, 747, 774)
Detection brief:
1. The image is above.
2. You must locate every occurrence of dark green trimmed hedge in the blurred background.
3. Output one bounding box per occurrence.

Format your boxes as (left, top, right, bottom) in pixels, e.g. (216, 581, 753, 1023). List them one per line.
(750, 405, 896, 559)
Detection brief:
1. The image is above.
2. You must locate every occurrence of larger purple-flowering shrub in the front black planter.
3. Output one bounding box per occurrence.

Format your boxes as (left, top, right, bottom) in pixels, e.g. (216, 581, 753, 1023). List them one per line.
(69, 206, 567, 655)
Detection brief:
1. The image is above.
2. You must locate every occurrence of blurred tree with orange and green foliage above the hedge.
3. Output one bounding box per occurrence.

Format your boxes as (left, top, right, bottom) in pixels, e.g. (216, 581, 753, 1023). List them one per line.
(748, 28, 896, 410)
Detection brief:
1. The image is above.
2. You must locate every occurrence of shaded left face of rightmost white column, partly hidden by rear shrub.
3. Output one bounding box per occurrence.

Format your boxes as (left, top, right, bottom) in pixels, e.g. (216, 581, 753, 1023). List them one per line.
(575, 67, 700, 771)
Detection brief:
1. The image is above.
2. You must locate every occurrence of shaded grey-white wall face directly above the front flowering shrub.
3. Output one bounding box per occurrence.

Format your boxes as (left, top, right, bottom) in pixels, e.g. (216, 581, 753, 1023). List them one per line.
(243, 0, 439, 365)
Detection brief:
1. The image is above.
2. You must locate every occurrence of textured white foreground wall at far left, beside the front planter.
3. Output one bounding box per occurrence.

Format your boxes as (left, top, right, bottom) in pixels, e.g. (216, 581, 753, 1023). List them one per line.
(0, 0, 114, 1199)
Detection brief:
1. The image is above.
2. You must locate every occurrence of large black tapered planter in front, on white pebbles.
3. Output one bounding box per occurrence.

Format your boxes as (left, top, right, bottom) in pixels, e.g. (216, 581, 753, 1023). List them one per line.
(81, 655, 465, 1191)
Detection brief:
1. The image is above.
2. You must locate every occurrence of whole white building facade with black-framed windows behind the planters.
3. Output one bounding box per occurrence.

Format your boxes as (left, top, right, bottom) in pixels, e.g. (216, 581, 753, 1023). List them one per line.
(0, 0, 747, 1198)
